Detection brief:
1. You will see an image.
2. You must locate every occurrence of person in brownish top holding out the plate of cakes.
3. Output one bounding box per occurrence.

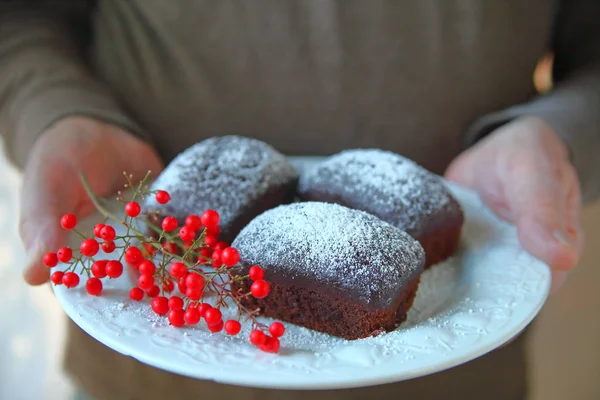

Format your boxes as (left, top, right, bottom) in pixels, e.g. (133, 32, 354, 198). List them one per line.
(0, 0, 600, 399)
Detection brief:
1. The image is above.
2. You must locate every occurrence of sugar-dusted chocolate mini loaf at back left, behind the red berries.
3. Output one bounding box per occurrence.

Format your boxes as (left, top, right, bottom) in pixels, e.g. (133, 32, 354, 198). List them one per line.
(144, 136, 298, 242)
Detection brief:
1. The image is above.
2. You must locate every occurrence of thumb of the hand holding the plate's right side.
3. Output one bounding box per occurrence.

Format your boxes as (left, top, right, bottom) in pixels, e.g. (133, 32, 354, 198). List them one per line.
(503, 160, 579, 270)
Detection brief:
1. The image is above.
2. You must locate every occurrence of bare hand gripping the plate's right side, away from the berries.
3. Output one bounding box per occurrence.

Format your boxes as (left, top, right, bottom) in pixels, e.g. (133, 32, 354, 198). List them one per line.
(446, 118, 583, 292)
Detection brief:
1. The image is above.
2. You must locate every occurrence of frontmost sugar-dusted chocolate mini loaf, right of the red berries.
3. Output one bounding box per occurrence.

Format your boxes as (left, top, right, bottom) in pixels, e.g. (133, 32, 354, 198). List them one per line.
(233, 202, 425, 339)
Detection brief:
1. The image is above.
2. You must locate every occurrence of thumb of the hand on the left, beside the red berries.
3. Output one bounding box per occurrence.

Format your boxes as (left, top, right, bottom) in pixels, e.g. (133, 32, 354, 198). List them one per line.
(19, 158, 77, 285)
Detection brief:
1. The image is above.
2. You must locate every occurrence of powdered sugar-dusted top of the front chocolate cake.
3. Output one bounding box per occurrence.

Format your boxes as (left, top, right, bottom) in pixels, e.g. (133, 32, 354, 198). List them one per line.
(232, 202, 425, 308)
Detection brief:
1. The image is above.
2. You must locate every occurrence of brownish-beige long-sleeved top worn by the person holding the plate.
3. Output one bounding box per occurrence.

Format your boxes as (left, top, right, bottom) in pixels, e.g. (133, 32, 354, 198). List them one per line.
(0, 0, 600, 398)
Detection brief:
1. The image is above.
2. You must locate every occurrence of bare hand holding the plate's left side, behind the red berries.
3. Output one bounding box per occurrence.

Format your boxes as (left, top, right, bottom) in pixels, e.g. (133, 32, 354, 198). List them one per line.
(19, 117, 162, 285)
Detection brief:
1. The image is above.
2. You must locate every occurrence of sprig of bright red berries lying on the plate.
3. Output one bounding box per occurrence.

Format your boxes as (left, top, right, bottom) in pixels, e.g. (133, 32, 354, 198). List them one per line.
(43, 173, 285, 353)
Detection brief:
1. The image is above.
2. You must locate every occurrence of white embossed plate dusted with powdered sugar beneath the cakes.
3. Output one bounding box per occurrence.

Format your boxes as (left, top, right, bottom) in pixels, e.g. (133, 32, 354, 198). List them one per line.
(55, 157, 550, 389)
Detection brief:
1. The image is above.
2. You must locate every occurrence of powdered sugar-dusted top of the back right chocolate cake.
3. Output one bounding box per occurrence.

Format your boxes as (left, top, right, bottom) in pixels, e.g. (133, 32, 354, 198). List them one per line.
(298, 149, 450, 233)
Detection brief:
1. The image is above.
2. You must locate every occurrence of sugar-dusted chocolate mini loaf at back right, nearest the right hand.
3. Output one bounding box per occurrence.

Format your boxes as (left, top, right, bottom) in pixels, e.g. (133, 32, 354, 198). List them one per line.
(298, 149, 464, 268)
